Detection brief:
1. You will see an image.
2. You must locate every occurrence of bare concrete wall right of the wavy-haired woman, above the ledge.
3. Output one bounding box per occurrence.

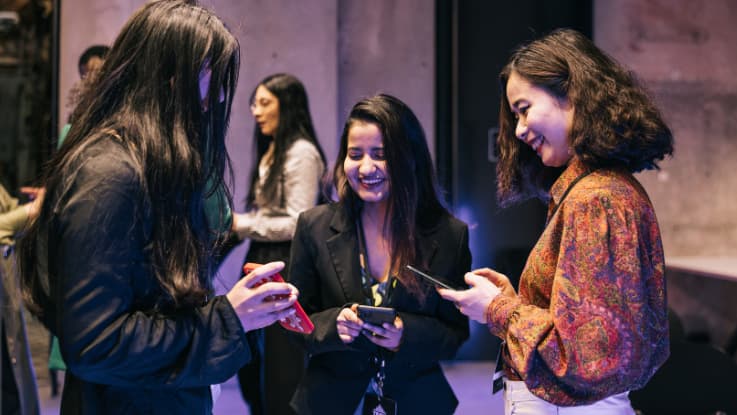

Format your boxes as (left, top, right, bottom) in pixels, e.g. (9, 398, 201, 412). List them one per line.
(594, 0, 737, 259)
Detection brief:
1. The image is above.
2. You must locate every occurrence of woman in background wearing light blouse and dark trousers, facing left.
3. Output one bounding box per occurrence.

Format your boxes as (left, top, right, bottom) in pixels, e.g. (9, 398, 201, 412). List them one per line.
(233, 73, 326, 415)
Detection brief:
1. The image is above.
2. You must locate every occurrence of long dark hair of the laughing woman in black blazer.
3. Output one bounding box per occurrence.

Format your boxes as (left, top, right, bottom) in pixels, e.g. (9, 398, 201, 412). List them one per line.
(333, 94, 450, 299)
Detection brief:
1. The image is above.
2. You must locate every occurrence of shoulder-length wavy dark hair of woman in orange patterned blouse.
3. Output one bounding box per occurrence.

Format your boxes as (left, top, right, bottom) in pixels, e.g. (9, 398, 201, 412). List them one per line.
(497, 29, 673, 205)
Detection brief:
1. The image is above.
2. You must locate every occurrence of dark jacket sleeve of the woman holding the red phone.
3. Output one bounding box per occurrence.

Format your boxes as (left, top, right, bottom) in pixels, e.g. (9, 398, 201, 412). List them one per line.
(49, 152, 250, 388)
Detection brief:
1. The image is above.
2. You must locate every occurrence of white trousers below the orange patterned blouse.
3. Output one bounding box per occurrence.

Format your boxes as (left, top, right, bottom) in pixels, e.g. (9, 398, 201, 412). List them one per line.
(504, 380, 635, 415)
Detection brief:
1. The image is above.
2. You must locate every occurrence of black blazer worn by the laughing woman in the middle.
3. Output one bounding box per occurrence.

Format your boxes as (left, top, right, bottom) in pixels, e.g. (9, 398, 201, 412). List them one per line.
(289, 204, 471, 414)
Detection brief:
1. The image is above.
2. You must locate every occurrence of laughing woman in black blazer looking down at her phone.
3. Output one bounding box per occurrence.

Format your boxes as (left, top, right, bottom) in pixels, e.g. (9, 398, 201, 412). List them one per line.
(289, 95, 471, 414)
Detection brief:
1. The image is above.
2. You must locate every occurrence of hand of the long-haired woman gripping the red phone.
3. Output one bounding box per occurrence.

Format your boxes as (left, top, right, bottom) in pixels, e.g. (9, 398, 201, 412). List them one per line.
(226, 261, 299, 331)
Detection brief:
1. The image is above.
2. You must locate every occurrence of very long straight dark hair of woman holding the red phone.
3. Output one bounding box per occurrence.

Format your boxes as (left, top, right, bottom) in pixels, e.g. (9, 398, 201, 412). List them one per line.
(20, 0, 240, 313)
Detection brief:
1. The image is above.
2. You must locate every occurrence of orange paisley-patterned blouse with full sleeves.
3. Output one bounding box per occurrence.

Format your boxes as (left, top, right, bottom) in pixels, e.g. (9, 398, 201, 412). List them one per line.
(488, 159, 669, 406)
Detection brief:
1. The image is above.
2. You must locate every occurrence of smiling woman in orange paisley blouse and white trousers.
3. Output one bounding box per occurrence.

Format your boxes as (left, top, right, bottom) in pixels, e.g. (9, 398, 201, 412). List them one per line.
(439, 29, 673, 414)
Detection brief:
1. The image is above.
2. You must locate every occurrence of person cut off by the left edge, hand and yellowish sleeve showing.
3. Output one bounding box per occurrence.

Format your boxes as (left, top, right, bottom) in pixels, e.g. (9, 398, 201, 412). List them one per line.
(0, 185, 44, 415)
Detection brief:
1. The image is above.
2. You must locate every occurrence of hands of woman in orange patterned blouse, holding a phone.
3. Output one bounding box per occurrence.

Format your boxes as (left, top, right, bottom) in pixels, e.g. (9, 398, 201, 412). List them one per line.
(438, 272, 506, 324)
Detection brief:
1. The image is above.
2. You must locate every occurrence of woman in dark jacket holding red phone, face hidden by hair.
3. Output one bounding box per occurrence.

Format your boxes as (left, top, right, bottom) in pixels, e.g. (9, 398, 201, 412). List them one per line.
(19, 0, 297, 415)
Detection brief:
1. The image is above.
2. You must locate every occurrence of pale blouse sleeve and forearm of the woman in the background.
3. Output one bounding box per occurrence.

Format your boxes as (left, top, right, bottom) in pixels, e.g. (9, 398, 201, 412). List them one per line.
(237, 140, 324, 242)
